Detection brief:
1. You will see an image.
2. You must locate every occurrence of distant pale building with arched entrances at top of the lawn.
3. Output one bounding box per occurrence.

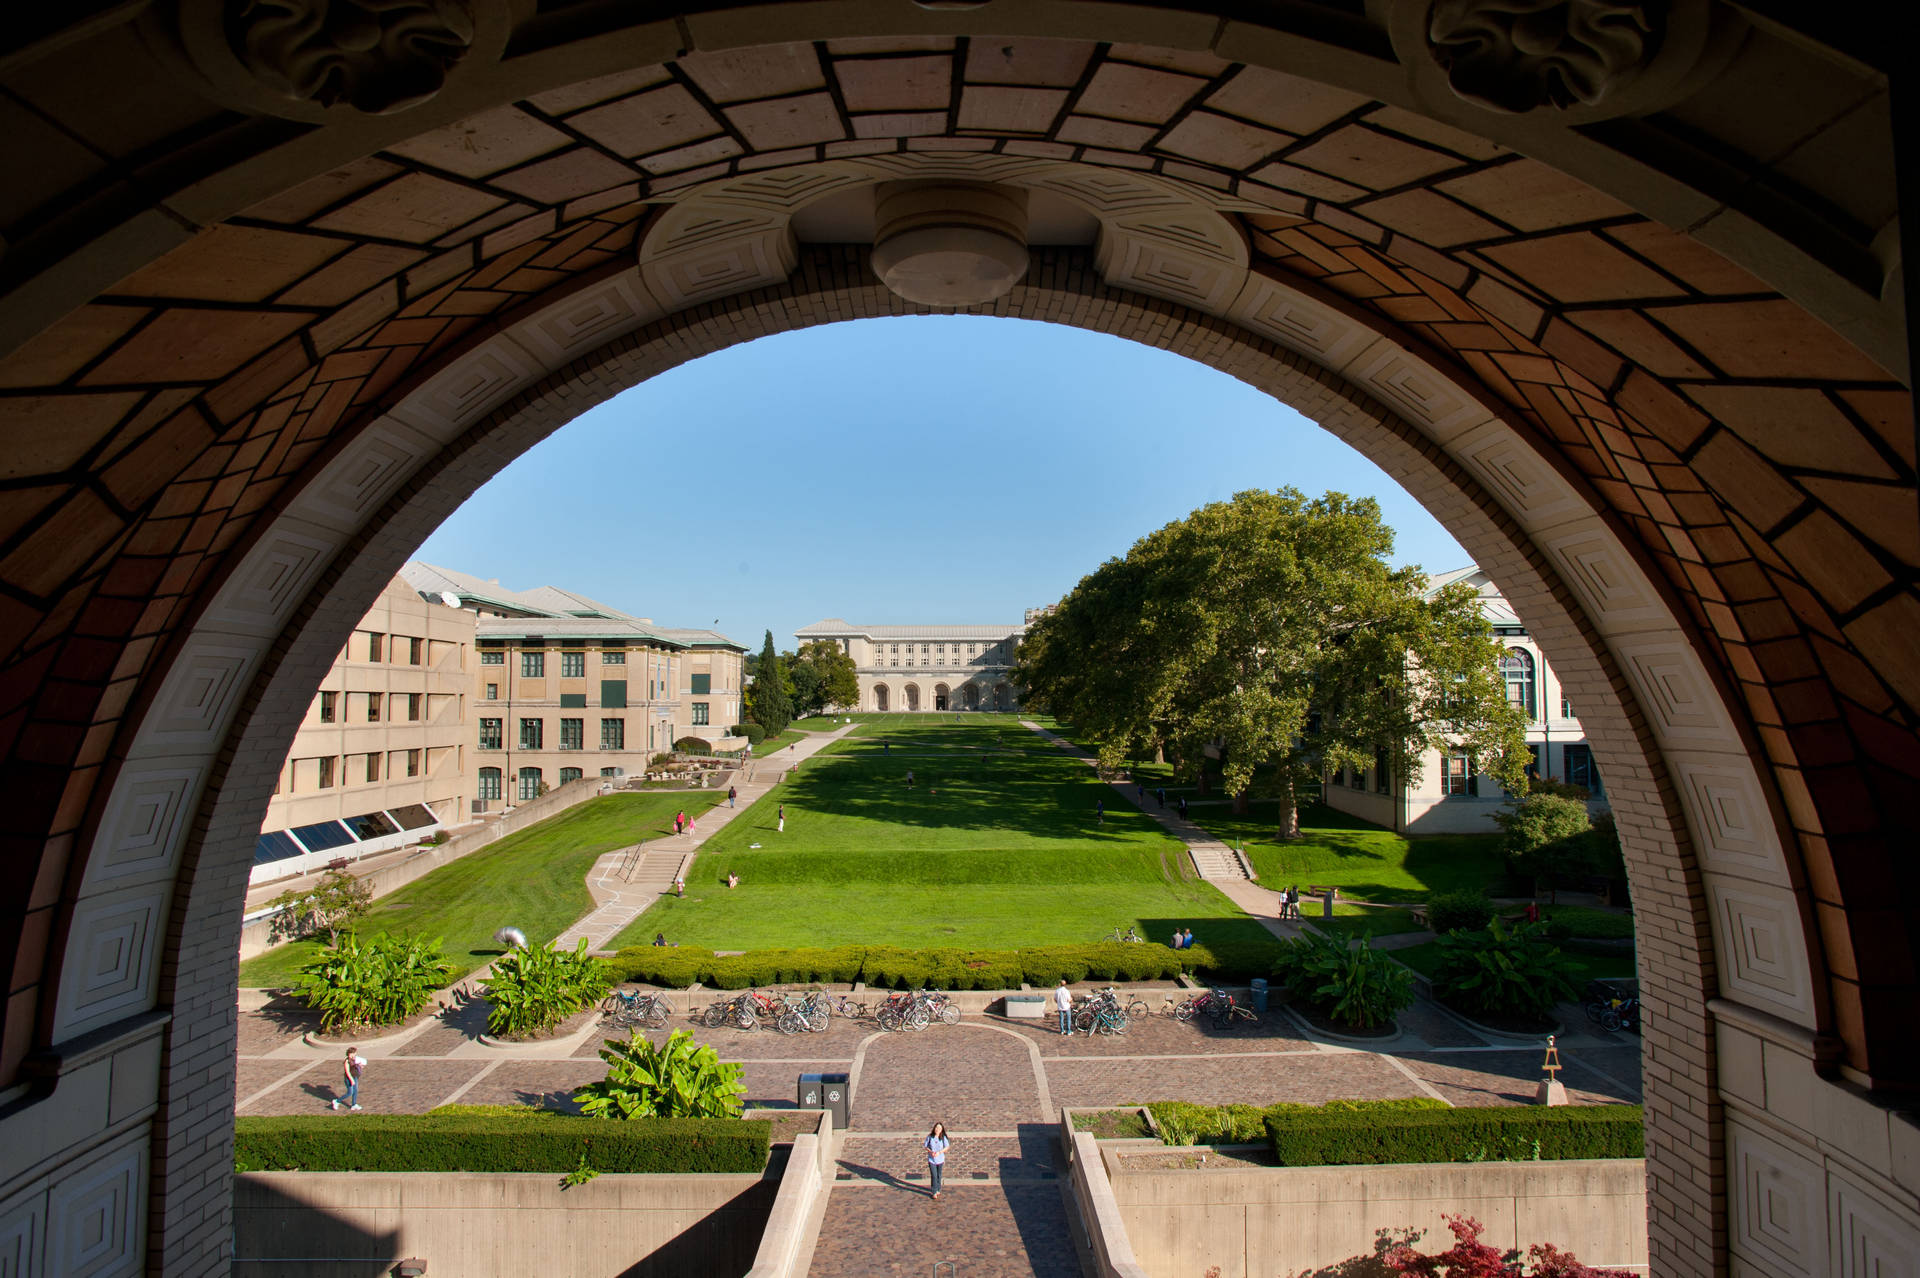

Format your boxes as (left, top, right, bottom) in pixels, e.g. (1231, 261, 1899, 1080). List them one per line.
(793, 614, 1031, 712)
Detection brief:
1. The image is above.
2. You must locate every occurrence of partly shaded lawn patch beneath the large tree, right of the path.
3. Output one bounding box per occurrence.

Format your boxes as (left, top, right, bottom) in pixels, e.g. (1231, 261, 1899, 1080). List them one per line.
(1190, 802, 1507, 902)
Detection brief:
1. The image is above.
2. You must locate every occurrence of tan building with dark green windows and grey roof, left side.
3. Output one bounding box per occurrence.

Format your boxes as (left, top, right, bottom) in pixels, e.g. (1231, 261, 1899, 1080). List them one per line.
(401, 562, 745, 790)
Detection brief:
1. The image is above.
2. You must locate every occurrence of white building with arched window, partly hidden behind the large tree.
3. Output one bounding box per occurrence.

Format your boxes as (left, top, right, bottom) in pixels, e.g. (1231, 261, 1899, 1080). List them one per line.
(1321, 566, 1607, 835)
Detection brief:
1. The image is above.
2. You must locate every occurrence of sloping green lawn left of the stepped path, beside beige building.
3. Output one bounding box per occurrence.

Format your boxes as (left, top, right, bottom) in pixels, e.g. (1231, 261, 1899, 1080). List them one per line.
(240, 791, 726, 986)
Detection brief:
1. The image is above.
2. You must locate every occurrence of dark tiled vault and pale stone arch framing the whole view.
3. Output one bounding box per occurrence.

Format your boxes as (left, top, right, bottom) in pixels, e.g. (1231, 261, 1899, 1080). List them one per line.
(0, 0, 1920, 1278)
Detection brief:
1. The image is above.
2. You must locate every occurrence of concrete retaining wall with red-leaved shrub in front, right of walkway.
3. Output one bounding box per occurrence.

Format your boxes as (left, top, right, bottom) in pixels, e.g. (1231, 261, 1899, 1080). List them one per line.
(1105, 1134, 1647, 1278)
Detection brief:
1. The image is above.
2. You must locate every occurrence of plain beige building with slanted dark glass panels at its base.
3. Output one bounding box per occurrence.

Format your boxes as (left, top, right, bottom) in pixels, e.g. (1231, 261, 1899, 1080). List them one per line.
(250, 578, 478, 883)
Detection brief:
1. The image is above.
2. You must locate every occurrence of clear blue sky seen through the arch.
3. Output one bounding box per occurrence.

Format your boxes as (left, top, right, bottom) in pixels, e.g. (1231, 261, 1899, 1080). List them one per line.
(417, 317, 1469, 651)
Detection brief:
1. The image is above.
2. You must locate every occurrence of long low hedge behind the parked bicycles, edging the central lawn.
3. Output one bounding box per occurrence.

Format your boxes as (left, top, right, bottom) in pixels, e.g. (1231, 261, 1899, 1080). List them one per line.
(609, 942, 1281, 990)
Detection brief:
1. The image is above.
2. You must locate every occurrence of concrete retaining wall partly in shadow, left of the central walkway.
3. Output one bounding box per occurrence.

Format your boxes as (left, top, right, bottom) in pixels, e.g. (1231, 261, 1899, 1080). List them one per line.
(232, 1149, 775, 1278)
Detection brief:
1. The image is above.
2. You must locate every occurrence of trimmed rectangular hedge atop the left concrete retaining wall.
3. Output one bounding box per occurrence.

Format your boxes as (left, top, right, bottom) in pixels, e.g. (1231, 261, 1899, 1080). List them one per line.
(234, 1109, 774, 1172)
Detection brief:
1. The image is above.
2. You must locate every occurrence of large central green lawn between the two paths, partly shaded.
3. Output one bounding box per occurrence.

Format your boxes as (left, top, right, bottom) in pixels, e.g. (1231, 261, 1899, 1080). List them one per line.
(614, 714, 1271, 950)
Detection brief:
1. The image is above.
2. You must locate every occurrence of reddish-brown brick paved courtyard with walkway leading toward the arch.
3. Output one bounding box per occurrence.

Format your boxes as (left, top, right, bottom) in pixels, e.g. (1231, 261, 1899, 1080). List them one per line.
(236, 994, 1640, 1278)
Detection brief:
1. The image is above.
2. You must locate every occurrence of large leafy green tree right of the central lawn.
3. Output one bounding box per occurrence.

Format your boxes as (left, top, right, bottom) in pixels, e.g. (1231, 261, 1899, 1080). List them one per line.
(1016, 487, 1526, 839)
